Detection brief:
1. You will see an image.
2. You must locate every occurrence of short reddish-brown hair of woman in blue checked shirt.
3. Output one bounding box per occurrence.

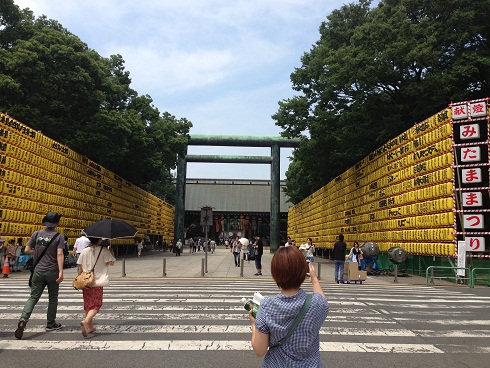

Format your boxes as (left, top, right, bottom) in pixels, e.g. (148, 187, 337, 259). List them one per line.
(271, 247, 307, 290)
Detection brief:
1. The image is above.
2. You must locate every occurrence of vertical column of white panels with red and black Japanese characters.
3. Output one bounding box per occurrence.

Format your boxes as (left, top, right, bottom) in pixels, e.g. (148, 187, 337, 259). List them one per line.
(451, 99, 490, 257)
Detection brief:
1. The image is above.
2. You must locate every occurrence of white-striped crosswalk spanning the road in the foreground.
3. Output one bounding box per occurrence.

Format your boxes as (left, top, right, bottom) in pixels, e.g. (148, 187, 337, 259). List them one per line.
(0, 280, 490, 354)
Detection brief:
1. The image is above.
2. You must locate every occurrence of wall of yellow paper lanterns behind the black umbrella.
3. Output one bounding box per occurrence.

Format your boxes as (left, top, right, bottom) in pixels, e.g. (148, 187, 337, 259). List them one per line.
(0, 113, 174, 244)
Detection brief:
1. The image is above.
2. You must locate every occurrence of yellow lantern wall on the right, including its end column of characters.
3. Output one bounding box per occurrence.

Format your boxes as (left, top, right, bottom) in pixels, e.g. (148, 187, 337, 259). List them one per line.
(288, 99, 490, 257)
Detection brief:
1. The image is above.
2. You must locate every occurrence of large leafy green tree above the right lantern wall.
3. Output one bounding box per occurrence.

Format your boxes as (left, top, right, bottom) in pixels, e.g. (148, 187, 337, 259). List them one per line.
(273, 0, 490, 203)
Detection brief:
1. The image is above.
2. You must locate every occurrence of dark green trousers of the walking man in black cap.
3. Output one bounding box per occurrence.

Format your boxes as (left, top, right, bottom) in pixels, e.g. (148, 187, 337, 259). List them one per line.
(20, 270, 60, 327)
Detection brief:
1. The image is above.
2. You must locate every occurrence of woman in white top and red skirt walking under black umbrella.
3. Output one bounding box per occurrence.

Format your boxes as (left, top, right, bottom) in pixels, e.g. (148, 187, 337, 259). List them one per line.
(77, 238, 116, 337)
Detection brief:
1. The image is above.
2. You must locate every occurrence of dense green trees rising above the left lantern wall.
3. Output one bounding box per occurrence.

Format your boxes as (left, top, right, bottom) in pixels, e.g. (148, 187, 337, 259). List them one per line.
(0, 0, 192, 201)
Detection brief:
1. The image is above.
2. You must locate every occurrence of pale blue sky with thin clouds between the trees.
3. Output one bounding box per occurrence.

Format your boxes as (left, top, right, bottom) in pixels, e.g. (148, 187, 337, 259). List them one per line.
(14, 0, 348, 180)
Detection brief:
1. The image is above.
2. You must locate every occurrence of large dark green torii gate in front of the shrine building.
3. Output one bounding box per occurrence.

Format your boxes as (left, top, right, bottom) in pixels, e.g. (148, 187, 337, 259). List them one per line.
(174, 135, 300, 252)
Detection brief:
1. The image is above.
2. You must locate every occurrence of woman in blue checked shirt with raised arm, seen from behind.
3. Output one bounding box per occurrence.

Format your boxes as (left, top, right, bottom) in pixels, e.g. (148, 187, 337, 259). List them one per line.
(249, 247, 328, 368)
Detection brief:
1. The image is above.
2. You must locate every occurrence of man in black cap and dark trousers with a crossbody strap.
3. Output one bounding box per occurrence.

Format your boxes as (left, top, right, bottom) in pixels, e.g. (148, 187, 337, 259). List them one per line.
(15, 212, 65, 339)
